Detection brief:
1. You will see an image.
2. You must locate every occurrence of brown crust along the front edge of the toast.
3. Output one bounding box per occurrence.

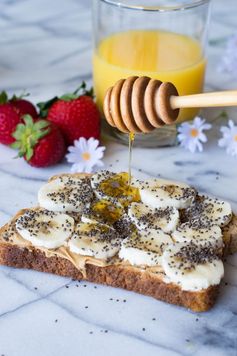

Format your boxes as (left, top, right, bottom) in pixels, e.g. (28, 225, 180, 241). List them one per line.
(0, 243, 219, 312)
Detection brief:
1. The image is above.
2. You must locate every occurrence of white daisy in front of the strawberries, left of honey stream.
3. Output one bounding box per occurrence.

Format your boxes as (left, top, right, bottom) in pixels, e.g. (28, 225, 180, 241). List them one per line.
(66, 137, 105, 173)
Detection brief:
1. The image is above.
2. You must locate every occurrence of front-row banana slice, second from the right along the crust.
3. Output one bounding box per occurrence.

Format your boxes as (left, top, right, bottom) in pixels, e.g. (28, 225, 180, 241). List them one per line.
(119, 230, 173, 266)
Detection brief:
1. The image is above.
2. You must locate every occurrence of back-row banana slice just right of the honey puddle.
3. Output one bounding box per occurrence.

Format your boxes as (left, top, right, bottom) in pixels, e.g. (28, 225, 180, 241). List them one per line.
(132, 179, 196, 209)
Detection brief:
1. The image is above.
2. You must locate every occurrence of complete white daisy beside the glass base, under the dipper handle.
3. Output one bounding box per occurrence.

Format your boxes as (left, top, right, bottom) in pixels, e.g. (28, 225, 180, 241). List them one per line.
(177, 116, 212, 153)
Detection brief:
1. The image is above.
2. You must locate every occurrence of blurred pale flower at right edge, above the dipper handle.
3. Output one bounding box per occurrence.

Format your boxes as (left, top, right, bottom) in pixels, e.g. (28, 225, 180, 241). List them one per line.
(218, 34, 237, 76)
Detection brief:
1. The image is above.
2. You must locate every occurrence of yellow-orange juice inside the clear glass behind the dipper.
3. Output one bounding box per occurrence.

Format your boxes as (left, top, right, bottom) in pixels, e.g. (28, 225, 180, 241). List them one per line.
(93, 30, 206, 121)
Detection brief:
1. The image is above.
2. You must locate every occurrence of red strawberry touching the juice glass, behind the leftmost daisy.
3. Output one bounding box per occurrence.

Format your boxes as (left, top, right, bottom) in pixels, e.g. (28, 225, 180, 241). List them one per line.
(38, 82, 100, 145)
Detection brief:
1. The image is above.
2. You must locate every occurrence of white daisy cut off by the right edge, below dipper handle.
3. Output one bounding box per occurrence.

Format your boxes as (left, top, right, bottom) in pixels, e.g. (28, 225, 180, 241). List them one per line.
(218, 120, 237, 156)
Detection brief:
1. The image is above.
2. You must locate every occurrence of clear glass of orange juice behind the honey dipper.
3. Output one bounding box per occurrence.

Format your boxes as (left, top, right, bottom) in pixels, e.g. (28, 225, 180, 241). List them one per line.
(93, 0, 210, 147)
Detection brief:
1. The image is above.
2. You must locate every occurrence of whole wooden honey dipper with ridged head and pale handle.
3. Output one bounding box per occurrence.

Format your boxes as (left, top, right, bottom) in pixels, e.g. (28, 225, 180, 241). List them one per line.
(104, 76, 237, 133)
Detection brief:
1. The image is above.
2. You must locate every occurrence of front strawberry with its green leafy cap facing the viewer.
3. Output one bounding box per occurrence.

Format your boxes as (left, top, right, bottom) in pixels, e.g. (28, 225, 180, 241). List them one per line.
(11, 115, 66, 167)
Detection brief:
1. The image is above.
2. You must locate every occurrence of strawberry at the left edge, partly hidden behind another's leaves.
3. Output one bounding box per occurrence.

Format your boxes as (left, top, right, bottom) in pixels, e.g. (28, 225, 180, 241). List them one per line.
(0, 91, 37, 145)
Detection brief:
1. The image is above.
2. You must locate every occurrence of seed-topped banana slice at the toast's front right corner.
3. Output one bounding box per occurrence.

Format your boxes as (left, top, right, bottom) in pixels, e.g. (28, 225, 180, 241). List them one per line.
(161, 242, 224, 291)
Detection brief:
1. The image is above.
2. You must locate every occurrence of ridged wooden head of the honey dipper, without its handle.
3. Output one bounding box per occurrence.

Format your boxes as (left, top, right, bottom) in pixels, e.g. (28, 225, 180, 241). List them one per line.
(104, 77, 179, 133)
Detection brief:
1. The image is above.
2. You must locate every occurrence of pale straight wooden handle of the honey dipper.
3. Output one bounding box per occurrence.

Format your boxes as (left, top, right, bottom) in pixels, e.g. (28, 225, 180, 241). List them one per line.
(170, 90, 237, 109)
